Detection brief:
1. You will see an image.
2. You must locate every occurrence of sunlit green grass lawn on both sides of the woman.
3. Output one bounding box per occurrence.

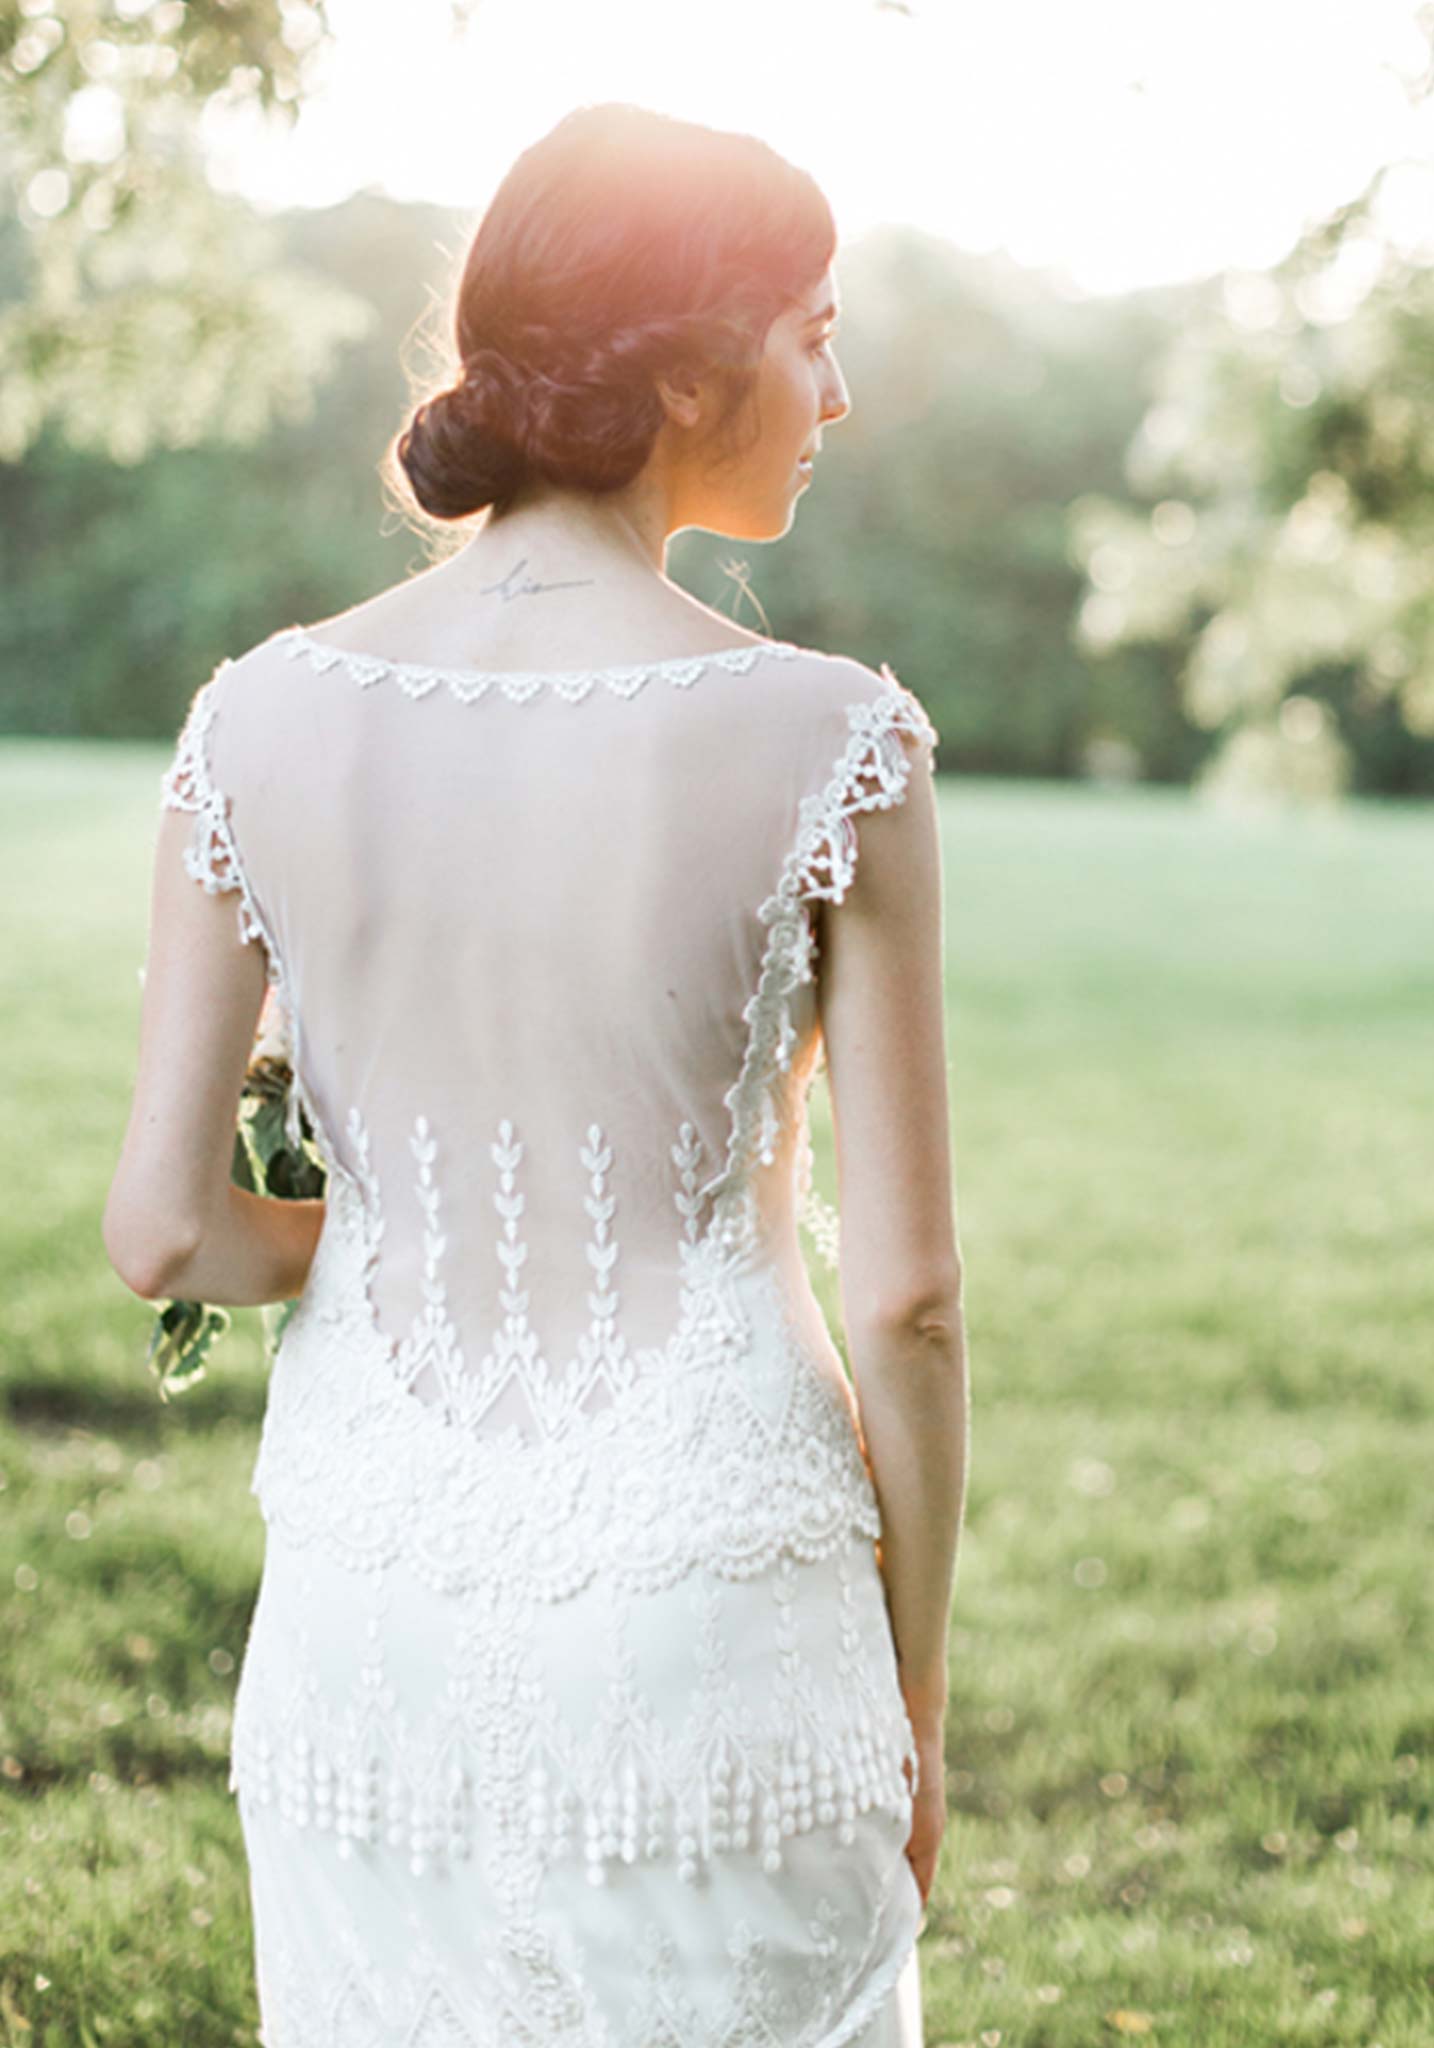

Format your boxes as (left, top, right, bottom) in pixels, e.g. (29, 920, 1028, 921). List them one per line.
(0, 739, 1434, 2048)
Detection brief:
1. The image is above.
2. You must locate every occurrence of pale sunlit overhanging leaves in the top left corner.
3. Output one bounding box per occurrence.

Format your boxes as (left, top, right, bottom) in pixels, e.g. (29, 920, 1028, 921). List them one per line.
(0, 0, 371, 463)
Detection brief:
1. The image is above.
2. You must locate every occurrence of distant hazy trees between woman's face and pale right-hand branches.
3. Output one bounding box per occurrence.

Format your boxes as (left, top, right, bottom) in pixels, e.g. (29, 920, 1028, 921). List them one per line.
(672, 225, 1209, 782)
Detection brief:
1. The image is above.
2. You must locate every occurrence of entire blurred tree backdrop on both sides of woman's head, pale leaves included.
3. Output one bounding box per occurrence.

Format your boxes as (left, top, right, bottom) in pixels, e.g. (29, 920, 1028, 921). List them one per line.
(11, 0, 1434, 797)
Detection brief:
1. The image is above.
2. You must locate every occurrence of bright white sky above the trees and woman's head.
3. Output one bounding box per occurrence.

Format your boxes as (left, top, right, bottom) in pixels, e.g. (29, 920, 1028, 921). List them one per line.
(207, 0, 1434, 297)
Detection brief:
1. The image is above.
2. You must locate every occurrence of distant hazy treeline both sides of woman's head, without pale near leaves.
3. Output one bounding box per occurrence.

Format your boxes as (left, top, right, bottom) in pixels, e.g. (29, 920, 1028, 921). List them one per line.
(0, 195, 1207, 780)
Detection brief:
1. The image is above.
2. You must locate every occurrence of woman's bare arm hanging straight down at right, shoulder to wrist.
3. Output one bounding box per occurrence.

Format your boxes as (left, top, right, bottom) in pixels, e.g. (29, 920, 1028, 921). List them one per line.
(817, 741, 969, 1716)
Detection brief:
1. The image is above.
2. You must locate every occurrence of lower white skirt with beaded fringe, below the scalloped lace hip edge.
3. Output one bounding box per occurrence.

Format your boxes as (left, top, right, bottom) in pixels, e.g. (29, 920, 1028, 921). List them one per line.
(231, 1530, 922, 2048)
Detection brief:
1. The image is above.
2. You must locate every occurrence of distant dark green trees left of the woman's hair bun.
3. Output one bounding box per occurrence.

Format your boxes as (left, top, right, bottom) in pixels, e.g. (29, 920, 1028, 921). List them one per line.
(0, 193, 456, 737)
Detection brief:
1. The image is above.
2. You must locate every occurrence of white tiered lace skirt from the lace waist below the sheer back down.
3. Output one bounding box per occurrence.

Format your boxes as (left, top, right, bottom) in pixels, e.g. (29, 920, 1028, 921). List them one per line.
(229, 1180, 922, 2048)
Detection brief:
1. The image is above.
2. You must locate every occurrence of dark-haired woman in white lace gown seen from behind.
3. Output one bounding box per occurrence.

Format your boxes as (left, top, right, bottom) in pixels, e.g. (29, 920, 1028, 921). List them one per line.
(104, 106, 965, 2048)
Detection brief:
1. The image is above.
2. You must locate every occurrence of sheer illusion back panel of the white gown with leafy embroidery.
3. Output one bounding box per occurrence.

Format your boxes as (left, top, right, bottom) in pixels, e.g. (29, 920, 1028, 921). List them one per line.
(195, 633, 934, 1440)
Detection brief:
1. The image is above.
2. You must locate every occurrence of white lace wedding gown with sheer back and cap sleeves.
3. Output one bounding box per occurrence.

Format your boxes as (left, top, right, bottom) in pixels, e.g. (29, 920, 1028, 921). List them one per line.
(164, 627, 936, 2048)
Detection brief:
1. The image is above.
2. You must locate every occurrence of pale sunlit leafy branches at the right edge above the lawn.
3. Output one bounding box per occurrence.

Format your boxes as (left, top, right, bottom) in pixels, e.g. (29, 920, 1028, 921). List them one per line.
(1071, 6, 1434, 795)
